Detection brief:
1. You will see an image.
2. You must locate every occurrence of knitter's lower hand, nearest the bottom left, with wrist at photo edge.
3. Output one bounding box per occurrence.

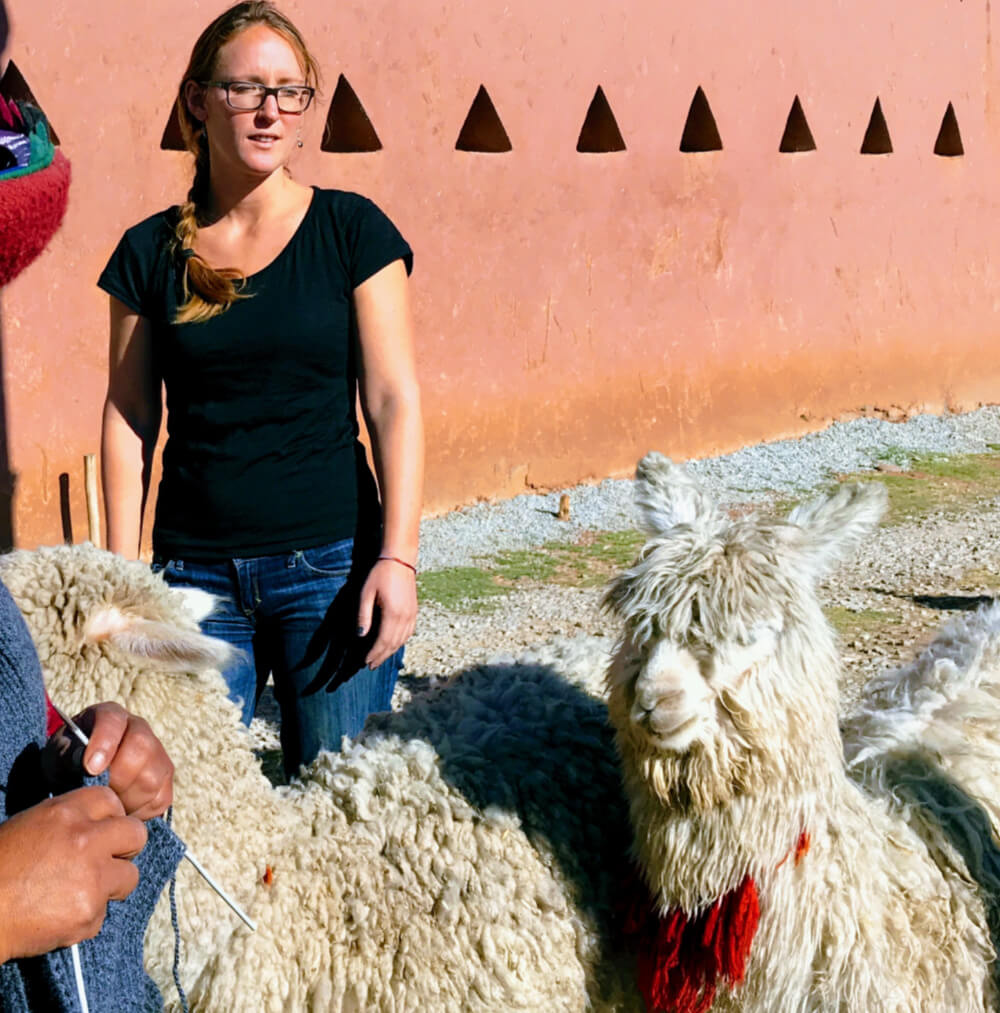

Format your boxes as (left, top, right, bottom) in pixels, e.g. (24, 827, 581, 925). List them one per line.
(0, 786, 146, 962)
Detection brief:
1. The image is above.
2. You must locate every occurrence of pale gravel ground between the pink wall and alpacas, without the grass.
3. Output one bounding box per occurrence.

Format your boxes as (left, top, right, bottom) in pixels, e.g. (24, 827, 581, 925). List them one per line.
(401, 406, 1000, 705)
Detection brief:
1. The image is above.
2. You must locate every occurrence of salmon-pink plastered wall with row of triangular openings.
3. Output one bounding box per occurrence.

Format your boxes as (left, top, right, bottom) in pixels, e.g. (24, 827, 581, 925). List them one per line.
(0, 0, 1000, 545)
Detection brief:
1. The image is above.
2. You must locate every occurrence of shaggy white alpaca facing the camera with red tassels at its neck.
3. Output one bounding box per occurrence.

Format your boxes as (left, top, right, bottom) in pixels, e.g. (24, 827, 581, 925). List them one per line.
(607, 454, 1000, 1013)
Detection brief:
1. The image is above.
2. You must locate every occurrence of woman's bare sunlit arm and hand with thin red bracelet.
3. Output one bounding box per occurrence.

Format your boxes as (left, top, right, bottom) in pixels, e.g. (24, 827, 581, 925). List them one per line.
(355, 260, 424, 669)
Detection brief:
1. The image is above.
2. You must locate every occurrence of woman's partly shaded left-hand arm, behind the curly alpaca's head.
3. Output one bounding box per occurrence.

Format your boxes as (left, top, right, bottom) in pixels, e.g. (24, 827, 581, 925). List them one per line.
(100, 296, 162, 559)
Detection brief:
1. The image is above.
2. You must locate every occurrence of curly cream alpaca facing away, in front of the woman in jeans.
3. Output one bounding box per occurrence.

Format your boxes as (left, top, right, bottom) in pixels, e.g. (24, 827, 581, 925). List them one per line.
(0, 546, 642, 1013)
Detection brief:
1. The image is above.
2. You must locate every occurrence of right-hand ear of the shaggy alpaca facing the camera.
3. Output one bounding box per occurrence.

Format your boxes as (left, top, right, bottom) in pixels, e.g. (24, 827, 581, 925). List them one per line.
(788, 482, 889, 579)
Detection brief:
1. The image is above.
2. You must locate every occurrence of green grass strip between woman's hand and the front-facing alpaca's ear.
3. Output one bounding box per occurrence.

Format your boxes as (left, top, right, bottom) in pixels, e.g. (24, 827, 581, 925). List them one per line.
(416, 531, 645, 612)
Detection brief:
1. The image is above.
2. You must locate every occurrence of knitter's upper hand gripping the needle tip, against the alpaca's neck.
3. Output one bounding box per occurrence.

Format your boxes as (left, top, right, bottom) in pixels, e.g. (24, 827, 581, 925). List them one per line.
(46, 703, 173, 820)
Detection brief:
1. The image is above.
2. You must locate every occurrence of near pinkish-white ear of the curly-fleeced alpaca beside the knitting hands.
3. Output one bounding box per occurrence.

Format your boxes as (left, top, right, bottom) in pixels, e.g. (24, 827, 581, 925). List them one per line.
(83, 605, 233, 671)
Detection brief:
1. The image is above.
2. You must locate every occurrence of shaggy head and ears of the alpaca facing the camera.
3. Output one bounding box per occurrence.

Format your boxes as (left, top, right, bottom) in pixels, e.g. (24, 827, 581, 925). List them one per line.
(606, 455, 884, 783)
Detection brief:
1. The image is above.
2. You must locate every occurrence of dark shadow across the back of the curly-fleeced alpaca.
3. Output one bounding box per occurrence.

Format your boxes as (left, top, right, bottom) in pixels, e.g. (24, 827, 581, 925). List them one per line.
(365, 664, 635, 1005)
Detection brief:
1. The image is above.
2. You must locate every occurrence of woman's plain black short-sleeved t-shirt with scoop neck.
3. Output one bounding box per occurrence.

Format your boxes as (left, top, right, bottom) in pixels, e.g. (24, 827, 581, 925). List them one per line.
(97, 187, 413, 560)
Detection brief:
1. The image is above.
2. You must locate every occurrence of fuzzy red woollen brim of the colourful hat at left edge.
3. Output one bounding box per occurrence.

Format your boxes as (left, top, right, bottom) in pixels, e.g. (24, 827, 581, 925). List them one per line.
(0, 150, 70, 288)
